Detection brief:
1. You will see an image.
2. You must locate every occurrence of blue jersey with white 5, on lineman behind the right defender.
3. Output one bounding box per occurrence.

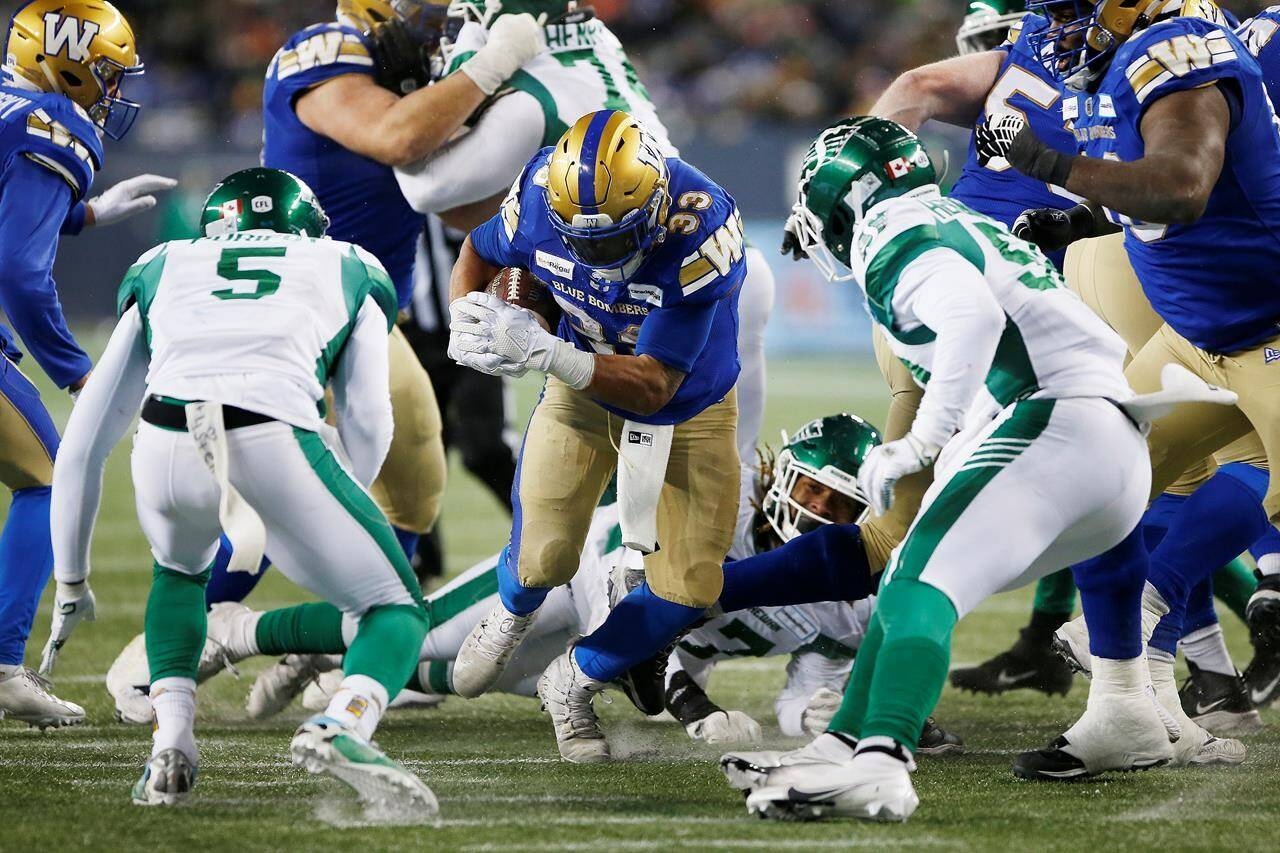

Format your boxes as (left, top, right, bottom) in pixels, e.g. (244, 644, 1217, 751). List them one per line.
(951, 14, 1082, 269)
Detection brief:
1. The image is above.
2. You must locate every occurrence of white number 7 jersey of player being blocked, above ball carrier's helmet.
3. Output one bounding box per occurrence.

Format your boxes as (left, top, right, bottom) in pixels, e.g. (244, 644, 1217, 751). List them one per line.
(445, 18, 680, 158)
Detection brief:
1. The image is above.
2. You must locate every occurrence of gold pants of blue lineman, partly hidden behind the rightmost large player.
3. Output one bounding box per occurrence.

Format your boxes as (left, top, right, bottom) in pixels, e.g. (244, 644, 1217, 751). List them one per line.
(1062, 234, 1267, 494)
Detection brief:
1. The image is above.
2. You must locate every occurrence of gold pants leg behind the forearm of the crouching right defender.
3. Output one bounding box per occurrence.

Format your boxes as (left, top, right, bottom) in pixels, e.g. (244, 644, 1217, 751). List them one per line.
(861, 328, 933, 575)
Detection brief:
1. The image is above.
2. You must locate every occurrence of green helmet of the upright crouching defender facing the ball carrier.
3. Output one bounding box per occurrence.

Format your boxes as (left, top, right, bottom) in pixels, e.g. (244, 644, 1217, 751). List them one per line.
(787, 115, 938, 282)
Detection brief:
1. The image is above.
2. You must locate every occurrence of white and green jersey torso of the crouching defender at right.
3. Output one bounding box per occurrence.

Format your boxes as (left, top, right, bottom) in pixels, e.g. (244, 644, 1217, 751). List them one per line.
(850, 192, 1133, 425)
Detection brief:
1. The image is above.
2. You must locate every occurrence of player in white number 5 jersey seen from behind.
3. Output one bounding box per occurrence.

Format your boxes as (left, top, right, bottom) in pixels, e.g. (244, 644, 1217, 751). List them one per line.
(52, 168, 436, 815)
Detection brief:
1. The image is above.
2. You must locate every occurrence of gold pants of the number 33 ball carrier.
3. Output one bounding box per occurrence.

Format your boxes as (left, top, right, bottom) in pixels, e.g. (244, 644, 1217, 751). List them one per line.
(508, 377, 740, 607)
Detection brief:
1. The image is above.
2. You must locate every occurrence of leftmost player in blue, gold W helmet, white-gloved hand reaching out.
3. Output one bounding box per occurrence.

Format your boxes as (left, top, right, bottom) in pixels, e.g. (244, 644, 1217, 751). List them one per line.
(0, 0, 175, 727)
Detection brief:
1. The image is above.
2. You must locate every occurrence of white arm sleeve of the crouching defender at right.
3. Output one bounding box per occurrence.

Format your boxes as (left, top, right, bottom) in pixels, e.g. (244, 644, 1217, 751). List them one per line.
(892, 247, 1005, 447)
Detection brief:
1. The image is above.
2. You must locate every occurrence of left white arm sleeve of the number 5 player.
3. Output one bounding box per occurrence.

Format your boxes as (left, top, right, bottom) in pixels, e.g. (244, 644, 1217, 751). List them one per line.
(50, 306, 148, 583)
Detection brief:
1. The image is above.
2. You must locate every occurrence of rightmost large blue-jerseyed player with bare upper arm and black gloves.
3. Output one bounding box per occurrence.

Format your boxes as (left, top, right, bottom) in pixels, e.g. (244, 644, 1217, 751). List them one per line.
(984, 0, 1280, 747)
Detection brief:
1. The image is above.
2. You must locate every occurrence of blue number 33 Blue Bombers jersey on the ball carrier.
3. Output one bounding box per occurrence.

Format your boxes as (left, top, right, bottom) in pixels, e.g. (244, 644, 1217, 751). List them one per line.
(471, 147, 746, 424)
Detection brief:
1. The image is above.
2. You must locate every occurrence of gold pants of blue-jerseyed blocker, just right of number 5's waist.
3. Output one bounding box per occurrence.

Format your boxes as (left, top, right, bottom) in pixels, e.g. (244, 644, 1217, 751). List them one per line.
(370, 327, 445, 533)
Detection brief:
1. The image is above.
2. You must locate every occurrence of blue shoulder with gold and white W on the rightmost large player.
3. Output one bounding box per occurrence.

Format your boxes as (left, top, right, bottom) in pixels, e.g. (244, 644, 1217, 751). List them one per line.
(1116, 18, 1252, 104)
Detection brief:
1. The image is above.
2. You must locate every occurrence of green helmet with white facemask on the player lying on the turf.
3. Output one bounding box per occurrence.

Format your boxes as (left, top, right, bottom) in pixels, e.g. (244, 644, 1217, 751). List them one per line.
(760, 412, 881, 542)
